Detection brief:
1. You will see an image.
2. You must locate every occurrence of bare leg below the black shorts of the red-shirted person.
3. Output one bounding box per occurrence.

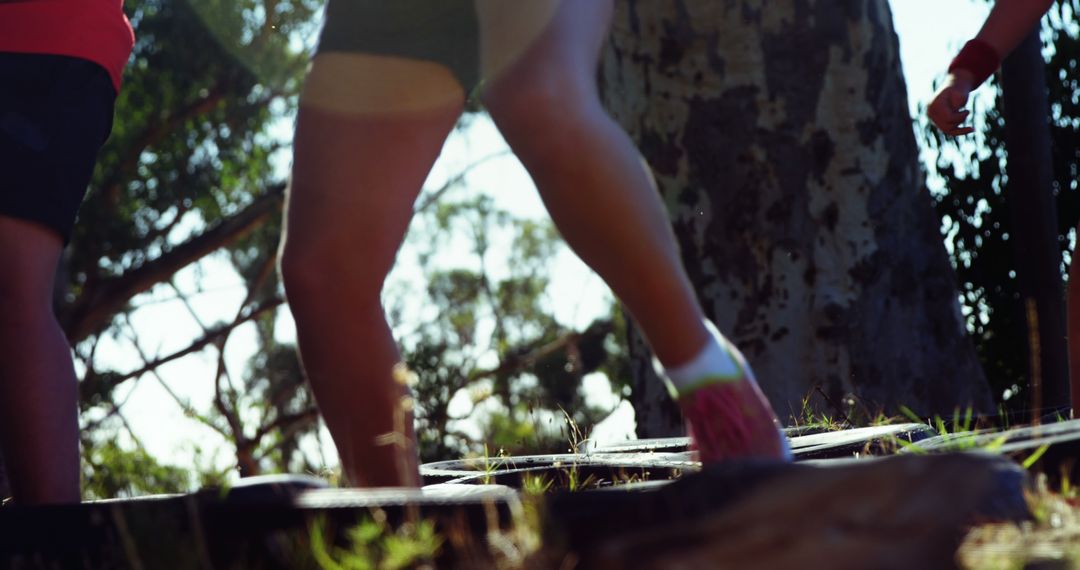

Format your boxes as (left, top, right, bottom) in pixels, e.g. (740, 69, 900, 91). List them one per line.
(0, 216, 81, 504)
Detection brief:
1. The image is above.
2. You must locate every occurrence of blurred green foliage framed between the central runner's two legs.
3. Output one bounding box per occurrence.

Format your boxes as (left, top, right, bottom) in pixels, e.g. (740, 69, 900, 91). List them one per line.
(399, 180, 625, 461)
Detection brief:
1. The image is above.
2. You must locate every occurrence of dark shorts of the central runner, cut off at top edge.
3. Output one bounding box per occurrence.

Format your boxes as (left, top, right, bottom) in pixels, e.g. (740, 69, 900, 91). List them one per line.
(319, 0, 479, 93)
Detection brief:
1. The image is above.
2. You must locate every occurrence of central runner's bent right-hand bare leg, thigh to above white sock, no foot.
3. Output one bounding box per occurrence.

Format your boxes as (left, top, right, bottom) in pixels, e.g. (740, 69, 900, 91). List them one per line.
(477, 0, 708, 365)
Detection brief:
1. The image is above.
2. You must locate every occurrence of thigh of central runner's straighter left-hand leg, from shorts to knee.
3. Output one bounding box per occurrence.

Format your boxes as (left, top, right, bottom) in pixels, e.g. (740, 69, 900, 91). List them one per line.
(283, 53, 464, 281)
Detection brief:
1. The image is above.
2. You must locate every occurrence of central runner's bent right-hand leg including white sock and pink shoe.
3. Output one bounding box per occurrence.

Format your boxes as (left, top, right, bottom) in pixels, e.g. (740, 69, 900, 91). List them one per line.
(476, 0, 787, 455)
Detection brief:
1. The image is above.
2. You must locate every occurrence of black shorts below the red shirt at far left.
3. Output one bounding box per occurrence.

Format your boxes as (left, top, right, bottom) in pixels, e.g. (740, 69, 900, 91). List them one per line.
(0, 53, 117, 243)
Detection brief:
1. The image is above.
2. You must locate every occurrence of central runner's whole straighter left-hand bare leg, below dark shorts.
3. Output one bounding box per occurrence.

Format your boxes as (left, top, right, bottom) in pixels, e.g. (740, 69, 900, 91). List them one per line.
(282, 54, 464, 487)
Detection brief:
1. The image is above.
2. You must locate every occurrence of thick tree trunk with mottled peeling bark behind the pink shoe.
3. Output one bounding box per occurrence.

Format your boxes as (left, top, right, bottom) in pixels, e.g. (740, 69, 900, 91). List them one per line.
(602, 0, 993, 424)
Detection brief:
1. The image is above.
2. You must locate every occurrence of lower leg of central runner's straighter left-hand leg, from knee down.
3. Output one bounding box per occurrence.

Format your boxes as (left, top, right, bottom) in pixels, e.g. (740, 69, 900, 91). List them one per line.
(282, 242, 419, 487)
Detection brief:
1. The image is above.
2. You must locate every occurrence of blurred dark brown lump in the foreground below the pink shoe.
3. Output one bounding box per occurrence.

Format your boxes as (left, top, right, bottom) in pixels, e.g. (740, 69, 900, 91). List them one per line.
(551, 453, 1028, 569)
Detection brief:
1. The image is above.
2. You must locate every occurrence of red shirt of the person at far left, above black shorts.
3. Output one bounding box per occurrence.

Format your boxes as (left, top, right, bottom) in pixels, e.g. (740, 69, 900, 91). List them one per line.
(0, 0, 135, 91)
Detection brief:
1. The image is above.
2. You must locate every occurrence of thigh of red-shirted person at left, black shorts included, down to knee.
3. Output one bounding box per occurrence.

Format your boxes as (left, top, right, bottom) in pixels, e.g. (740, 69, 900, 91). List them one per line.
(0, 53, 116, 304)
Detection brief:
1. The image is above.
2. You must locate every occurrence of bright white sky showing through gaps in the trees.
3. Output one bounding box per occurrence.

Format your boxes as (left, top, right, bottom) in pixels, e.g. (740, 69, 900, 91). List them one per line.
(99, 0, 987, 479)
